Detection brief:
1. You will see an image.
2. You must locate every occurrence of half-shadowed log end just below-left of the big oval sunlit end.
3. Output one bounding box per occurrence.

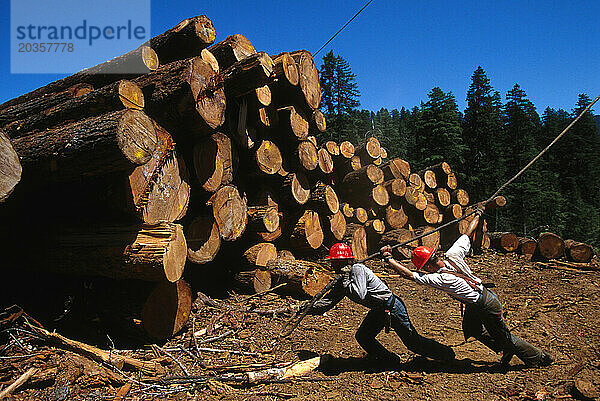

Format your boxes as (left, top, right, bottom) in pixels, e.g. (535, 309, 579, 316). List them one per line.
(186, 215, 221, 264)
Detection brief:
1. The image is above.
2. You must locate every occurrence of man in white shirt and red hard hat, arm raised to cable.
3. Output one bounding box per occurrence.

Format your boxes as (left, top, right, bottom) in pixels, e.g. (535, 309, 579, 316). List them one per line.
(381, 208, 554, 366)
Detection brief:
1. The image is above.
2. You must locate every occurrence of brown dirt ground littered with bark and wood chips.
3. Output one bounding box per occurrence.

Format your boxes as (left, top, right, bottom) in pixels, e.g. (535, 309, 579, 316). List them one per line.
(0, 252, 600, 401)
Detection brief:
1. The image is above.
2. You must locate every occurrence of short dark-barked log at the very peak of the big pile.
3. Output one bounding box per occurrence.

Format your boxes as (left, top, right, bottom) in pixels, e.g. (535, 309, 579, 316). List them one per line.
(150, 15, 216, 64)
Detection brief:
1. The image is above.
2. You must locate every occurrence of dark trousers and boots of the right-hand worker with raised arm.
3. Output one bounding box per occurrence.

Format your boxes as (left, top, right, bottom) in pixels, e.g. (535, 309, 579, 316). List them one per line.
(462, 289, 544, 365)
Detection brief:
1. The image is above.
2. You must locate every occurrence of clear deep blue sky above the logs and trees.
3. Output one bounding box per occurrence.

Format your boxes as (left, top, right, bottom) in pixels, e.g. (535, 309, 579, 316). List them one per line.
(0, 0, 600, 113)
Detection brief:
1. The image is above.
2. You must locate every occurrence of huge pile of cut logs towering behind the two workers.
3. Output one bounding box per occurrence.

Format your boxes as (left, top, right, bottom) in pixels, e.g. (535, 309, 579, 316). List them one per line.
(0, 16, 506, 337)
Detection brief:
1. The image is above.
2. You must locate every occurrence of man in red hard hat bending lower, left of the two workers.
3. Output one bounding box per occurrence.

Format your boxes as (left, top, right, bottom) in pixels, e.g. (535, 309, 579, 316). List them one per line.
(310, 243, 454, 362)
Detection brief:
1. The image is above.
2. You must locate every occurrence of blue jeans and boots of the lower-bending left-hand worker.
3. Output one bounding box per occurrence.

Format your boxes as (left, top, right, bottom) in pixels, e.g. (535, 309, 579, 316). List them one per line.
(356, 295, 454, 360)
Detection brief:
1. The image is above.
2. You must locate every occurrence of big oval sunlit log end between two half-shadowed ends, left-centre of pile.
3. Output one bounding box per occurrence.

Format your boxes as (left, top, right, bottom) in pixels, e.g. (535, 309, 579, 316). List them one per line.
(208, 185, 248, 241)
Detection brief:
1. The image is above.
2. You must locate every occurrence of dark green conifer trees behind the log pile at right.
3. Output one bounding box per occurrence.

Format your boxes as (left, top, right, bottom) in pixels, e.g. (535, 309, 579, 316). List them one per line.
(319, 51, 600, 247)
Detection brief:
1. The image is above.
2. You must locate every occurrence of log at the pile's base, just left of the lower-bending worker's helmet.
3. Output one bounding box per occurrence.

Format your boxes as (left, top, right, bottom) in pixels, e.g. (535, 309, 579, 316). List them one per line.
(267, 258, 331, 298)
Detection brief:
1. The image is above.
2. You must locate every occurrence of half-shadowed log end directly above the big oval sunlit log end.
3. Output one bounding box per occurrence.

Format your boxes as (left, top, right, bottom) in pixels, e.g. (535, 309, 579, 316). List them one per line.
(193, 132, 234, 192)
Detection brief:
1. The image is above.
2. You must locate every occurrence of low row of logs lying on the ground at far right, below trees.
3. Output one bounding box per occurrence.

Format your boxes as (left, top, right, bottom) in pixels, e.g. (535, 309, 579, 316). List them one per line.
(489, 232, 594, 263)
